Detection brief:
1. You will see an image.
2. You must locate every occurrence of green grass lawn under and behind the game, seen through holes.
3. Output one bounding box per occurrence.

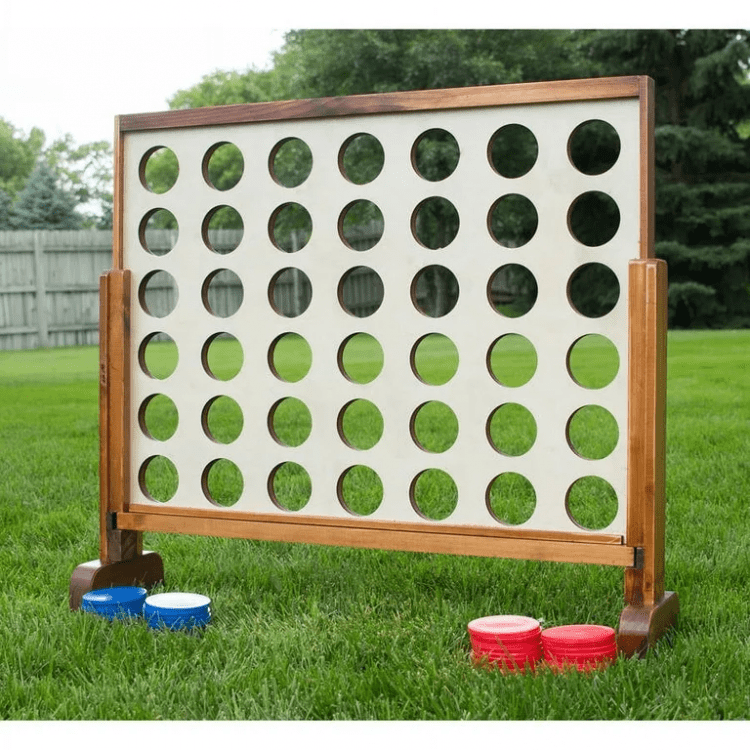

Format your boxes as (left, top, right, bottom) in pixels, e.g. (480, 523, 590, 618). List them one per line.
(0, 331, 750, 720)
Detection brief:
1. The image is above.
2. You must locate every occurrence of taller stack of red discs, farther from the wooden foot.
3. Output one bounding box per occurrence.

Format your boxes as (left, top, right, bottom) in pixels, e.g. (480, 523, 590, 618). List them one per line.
(468, 615, 542, 672)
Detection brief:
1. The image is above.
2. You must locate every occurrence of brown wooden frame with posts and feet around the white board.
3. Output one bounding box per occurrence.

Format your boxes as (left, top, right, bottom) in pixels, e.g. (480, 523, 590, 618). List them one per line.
(70, 76, 678, 655)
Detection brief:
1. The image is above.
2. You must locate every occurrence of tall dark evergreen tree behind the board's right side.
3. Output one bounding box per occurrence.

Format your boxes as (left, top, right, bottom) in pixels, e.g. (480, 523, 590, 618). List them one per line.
(587, 29, 750, 327)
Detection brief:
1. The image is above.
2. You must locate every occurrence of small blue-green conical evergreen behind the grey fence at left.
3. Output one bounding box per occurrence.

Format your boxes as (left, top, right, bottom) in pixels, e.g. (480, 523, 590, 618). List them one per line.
(11, 160, 82, 229)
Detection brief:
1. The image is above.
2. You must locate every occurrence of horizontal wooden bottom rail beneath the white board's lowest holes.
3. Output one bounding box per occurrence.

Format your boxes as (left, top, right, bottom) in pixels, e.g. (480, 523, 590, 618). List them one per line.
(117, 511, 635, 567)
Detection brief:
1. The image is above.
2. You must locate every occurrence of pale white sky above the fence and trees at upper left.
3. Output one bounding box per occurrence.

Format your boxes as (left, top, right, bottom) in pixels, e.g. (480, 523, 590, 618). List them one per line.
(0, 0, 289, 144)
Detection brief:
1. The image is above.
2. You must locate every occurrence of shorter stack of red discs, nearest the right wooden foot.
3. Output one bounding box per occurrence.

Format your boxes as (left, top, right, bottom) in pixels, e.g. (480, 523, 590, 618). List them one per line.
(541, 625, 617, 672)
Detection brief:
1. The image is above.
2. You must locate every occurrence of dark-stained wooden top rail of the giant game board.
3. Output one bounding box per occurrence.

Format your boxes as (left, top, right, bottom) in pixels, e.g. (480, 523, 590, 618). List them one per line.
(118, 76, 644, 133)
